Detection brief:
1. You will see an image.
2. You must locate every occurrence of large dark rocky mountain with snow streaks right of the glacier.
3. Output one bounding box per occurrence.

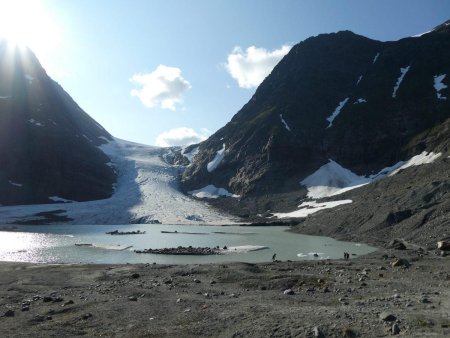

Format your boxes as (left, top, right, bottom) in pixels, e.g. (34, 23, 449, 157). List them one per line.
(182, 21, 450, 214)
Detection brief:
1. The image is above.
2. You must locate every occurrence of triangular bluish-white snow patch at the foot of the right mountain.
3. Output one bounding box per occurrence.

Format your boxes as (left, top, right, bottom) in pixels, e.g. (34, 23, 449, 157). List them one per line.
(300, 160, 371, 198)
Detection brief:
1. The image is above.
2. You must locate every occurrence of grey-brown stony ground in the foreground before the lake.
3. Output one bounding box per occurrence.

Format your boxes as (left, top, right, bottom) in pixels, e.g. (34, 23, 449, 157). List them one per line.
(0, 250, 450, 337)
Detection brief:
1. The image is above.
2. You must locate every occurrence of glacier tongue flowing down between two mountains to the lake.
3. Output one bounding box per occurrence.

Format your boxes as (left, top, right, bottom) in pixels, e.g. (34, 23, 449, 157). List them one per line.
(0, 139, 234, 224)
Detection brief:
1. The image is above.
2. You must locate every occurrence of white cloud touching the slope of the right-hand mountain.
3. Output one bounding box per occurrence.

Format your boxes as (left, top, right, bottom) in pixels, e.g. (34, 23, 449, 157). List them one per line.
(225, 45, 292, 88)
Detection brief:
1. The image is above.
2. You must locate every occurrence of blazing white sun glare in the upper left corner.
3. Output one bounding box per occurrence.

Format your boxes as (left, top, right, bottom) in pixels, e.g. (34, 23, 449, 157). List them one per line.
(0, 0, 59, 54)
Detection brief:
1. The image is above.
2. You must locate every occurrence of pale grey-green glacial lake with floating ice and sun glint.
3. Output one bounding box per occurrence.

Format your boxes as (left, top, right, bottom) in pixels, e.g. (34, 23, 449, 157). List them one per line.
(0, 224, 376, 264)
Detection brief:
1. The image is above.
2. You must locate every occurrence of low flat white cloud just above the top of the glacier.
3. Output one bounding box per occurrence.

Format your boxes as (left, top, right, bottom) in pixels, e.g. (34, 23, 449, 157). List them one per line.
(156, 127, 210, 147)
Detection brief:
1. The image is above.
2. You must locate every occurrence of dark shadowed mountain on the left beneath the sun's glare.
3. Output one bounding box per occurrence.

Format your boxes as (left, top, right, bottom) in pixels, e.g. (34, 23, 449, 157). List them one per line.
(0, 41, 115, 205)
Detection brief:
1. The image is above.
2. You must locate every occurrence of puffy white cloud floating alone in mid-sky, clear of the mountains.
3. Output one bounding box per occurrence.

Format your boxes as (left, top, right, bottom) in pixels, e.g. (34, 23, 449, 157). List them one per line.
(130, 65, 191, 110)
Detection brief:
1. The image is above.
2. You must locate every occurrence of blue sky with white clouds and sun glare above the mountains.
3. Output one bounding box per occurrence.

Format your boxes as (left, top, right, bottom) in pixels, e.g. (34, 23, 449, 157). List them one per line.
(0, 0, 450, 146)
